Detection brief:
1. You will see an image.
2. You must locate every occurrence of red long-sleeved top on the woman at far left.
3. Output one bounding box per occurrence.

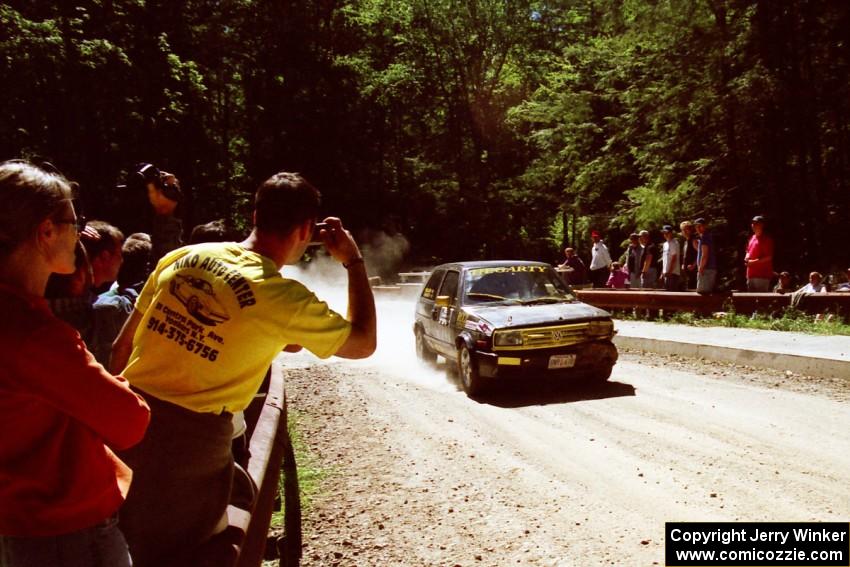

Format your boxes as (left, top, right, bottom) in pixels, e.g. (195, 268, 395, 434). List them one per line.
(0, 284, 150, 536)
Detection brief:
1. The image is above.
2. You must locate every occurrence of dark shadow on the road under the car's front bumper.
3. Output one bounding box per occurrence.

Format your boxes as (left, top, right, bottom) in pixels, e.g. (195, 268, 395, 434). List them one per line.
(468, 381, 635, 408)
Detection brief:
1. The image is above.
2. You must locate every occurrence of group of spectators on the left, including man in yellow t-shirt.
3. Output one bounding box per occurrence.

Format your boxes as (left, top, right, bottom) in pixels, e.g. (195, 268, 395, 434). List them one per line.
(0, 160, 376, 567)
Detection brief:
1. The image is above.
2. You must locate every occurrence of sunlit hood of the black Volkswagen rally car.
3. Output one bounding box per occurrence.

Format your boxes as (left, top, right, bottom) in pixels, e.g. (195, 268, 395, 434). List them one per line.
(466, 301, 611, 329)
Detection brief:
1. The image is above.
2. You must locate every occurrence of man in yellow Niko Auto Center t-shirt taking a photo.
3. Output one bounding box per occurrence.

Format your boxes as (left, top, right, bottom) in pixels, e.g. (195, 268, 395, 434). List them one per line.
(110, 172, 376, 567)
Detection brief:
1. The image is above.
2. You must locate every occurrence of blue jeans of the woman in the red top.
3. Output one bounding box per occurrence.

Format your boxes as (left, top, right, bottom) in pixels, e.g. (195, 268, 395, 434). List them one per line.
(0, 516, 132, 567)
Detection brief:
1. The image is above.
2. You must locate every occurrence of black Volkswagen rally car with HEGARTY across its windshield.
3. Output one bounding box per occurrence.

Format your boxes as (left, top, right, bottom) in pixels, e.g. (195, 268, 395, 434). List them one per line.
(413, 261, 617, 395)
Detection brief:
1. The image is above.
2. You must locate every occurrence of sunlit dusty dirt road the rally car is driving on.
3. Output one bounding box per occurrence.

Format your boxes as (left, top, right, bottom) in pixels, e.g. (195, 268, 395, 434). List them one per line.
(282, 300, 850, 566)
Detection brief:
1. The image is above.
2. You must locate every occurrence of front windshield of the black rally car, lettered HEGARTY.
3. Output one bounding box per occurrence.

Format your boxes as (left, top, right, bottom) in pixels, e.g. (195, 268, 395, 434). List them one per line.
(463, 265, 575, 305)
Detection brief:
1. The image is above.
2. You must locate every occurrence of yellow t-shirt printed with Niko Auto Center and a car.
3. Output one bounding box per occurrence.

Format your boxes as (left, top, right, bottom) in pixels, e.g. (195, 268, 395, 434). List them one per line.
(123, 242, 351, 413)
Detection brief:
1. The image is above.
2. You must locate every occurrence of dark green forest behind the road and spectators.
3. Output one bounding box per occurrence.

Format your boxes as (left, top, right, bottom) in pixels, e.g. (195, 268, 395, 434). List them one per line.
(0, 0, 850, 287)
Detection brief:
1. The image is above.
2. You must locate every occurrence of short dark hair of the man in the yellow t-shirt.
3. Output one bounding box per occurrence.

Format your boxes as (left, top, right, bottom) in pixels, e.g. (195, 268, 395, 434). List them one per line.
(254, 171, 322, 236)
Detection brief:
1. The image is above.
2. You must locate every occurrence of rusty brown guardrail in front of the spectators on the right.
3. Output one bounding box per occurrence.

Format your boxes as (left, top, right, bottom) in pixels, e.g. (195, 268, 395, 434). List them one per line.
(575, 289, 850, 317)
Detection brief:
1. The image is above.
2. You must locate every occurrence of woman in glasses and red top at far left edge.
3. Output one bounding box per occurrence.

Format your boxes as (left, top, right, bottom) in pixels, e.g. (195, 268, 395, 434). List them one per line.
(0, 161, 150, 567)
